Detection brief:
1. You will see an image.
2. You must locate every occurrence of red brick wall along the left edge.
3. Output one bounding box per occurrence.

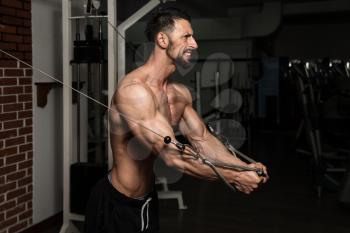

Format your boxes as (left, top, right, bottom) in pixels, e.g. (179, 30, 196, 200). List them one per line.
(0, 0, 33, 233)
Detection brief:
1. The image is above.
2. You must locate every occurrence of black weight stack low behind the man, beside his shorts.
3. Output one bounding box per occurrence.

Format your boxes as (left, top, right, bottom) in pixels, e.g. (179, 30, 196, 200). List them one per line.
(70, 163, 108, 215)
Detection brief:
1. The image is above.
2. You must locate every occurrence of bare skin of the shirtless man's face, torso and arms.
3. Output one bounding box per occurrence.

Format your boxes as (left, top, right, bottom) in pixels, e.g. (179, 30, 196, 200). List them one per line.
(110, 19, 267, 198)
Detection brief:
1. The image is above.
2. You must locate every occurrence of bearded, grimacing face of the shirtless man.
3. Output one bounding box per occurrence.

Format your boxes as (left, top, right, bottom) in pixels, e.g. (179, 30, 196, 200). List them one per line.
(166, 19, 198, 67)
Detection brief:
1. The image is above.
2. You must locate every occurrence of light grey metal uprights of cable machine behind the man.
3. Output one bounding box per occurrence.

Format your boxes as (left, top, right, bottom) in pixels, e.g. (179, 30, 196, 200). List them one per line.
(60, 0, 117, 233)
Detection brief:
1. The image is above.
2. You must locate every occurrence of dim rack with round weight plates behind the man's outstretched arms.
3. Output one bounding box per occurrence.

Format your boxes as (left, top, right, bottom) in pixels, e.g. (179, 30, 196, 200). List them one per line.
(194, 53, 259, 153)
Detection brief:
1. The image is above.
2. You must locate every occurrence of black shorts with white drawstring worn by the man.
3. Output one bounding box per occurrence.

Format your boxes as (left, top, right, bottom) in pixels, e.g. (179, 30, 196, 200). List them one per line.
(85, 176, 159, 233)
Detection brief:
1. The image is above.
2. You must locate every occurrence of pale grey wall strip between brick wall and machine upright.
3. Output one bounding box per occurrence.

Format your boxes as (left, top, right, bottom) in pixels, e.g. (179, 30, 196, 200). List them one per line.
(32, 0, 62, 227)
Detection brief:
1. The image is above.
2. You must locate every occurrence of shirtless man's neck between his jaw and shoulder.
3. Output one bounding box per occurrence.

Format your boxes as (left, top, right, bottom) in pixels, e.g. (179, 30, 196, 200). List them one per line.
(145, 47, 176, 86)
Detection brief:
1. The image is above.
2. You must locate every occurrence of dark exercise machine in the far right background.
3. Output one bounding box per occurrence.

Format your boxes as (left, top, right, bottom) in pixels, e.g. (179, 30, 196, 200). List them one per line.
(286, 60, 350, 197)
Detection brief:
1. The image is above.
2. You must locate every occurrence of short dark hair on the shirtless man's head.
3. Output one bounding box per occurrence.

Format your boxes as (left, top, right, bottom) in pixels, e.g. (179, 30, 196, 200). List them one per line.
(145, 7, 191, 42)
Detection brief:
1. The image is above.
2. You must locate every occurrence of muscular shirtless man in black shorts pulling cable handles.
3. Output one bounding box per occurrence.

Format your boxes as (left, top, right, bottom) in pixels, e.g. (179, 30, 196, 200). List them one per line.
(86, 9, 267, 233)
